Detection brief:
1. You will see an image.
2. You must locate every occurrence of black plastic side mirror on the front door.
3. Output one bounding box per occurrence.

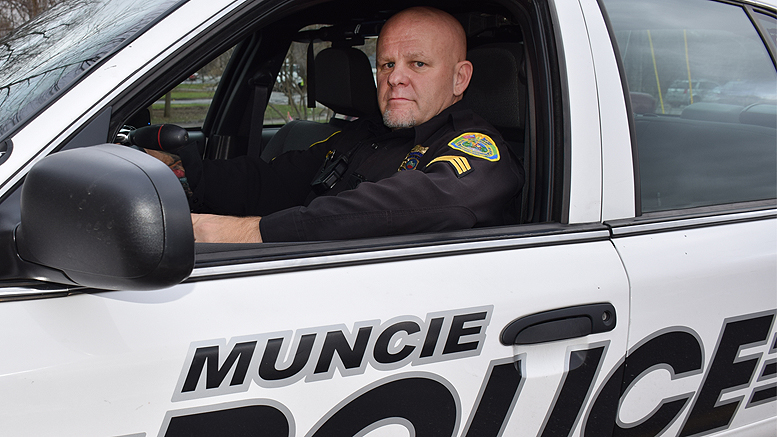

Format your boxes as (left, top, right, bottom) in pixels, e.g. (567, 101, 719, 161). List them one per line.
(15, 144, 194, 290)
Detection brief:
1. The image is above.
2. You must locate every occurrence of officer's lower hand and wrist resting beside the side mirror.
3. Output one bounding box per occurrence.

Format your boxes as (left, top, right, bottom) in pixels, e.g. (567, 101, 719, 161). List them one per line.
(192, 214, 262, 243)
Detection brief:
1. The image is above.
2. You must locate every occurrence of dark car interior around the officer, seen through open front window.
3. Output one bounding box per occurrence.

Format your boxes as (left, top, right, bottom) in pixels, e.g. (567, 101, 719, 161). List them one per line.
(110, 0, 564, 260)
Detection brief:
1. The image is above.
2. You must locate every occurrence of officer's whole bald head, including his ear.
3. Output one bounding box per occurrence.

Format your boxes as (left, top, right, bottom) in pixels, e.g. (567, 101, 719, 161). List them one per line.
(377, 7, 472, 129)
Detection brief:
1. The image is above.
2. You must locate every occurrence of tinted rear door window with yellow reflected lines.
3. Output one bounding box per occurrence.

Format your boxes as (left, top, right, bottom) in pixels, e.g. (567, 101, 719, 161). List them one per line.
(604, 0, 777, 212)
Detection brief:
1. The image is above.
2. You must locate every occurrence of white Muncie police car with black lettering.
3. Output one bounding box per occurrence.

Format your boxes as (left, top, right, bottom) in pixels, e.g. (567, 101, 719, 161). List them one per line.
(0, 0, 777, 437)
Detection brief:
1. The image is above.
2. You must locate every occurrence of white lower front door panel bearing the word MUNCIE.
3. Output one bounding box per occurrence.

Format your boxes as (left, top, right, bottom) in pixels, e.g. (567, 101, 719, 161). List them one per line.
(0, 232, 629, 435)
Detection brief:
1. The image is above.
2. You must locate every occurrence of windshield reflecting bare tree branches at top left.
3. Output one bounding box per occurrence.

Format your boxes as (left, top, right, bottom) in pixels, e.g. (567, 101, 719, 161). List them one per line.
(0, 0, 180, 139)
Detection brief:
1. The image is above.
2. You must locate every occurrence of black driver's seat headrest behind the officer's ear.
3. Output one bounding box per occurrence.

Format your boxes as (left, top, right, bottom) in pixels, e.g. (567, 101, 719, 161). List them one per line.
(464, 43, 526, 128)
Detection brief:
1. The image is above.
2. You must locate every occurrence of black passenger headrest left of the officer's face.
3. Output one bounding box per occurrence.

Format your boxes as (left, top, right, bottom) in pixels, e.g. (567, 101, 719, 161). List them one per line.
(315, 47, 379, 117)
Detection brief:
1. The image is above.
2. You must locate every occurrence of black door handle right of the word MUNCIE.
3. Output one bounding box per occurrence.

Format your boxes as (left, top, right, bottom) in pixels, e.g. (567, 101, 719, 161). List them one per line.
(499, 303, 616, 346)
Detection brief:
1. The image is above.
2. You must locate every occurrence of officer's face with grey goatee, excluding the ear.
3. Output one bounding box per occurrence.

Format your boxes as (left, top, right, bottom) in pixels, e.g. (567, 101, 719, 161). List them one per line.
(377, 15, 459, 129)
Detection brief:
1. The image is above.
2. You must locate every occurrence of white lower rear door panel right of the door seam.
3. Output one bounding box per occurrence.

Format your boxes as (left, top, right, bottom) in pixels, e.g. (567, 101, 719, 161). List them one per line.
(613, 210, 777, 435)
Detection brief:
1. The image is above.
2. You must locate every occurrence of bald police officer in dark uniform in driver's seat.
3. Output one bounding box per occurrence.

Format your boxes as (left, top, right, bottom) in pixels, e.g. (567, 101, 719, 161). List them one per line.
(184, 8, 524, 243)
